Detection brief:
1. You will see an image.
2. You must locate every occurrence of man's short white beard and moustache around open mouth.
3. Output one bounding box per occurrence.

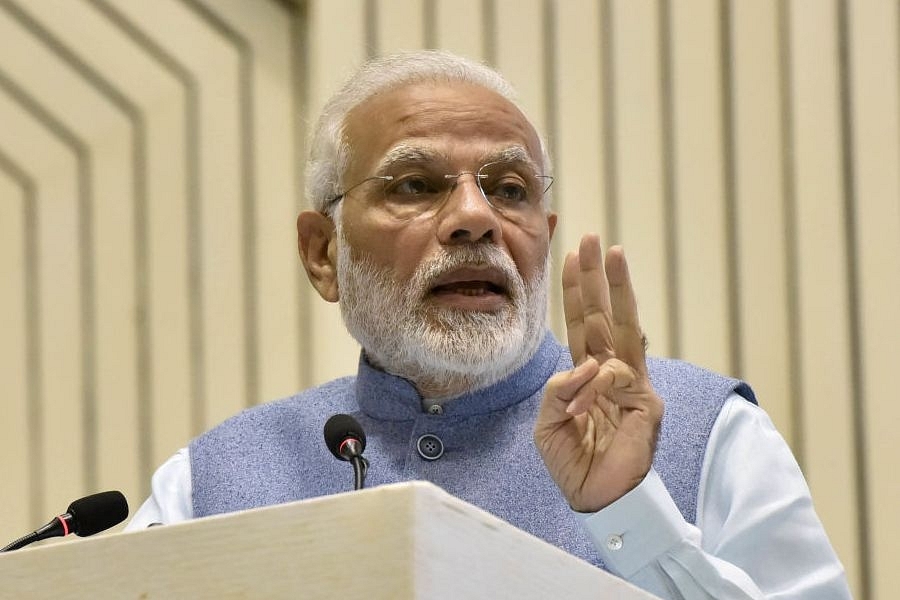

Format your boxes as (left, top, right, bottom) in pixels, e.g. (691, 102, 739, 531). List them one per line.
(335, 214, 549, 397)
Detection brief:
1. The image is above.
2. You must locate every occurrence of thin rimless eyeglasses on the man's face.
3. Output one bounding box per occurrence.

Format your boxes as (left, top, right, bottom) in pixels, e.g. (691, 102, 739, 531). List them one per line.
(326, 160, 553, 218)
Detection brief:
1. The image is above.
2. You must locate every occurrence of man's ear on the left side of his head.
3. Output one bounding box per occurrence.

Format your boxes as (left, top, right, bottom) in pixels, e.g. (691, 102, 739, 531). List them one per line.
(297, 210, 339, 302)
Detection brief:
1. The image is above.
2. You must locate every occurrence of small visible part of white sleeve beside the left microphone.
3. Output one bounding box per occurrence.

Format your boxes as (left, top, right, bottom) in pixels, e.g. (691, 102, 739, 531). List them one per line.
(125, 448, 194, 531)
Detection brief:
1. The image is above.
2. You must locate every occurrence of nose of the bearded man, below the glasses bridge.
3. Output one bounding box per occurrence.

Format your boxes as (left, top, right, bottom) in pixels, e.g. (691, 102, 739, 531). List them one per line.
(437, 173, 503, 245)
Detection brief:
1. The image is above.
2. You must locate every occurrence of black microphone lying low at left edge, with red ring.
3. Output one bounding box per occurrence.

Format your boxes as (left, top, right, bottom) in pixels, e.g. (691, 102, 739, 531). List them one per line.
(0, 491, 128, 552)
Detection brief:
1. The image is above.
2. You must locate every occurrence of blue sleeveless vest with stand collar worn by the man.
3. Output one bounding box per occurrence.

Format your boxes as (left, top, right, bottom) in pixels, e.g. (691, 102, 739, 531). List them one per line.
(190, 334, 755, 566)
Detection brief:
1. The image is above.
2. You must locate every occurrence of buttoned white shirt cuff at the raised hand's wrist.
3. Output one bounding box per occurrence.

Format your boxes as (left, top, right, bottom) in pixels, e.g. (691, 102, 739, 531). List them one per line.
(579, 469, 694, 579)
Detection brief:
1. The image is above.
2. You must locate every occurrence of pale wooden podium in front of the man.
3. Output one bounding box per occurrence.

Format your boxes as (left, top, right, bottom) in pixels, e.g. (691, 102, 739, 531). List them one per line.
(0, 482, 654, 600)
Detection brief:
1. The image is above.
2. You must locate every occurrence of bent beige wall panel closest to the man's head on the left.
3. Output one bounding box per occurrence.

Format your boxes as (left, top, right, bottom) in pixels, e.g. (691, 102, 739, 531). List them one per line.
(198, 0, 303, 402)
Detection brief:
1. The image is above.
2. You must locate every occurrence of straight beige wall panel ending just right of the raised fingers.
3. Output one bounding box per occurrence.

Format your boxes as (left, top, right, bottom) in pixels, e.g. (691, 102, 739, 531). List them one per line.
(607, 0, 670, 355)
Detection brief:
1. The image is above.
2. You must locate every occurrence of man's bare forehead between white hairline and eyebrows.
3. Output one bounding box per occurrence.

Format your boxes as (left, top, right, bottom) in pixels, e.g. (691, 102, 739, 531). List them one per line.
(345, 82, 541, 177)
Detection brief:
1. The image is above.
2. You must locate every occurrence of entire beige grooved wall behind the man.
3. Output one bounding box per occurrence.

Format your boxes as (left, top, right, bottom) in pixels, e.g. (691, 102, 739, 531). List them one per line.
(0, 0, 900, 599)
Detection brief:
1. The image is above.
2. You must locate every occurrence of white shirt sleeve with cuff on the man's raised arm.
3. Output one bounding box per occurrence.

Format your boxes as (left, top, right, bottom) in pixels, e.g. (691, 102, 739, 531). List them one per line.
(582, 395, 851, 600)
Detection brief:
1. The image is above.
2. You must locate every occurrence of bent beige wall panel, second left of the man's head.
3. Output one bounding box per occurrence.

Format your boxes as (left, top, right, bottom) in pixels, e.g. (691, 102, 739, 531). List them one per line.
(112, 0, 248, 429)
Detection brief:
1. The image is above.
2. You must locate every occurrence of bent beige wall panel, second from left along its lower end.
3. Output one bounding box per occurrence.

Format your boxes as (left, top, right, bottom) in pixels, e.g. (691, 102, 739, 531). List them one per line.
(0, 82, 85, 524)
